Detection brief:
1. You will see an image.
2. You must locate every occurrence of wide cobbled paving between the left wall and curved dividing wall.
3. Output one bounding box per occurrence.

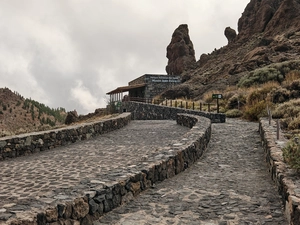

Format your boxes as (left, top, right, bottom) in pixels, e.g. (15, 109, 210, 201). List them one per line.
(0, 120, 189, 224)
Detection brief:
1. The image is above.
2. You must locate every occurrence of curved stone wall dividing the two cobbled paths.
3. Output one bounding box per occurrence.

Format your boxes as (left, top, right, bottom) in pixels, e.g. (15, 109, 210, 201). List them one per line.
(6, 114, 211, 225)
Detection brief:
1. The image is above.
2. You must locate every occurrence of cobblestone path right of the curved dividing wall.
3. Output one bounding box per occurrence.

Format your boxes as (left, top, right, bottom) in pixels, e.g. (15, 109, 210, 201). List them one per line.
(94, 119, 287, 225)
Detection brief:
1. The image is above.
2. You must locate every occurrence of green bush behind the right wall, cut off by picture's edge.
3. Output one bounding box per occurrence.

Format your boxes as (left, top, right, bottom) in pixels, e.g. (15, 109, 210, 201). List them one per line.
(282, 136, 300, 170)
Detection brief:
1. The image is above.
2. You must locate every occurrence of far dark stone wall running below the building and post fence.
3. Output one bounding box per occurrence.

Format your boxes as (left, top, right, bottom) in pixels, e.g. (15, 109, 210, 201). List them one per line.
(122, 102, 226, 123)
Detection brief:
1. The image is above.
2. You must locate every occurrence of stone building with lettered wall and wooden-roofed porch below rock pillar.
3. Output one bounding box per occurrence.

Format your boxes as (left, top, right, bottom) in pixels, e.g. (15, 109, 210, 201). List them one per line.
(106, 74, 181, 102)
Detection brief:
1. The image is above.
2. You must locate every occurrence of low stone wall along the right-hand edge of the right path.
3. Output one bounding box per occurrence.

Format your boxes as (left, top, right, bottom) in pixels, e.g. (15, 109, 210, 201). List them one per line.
(259, 118, 300, 225)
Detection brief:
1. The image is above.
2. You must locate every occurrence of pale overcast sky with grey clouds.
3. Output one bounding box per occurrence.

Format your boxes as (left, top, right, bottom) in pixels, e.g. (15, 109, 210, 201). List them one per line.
(0, 0, 250, 114)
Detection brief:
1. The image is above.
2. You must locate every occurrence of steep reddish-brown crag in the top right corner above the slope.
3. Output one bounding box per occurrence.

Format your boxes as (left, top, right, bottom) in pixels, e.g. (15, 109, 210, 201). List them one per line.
(238, 0, 300, 39)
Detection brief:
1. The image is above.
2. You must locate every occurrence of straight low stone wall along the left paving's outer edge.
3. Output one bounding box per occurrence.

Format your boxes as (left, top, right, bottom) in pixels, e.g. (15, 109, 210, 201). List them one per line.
(0, 113, 131, 161)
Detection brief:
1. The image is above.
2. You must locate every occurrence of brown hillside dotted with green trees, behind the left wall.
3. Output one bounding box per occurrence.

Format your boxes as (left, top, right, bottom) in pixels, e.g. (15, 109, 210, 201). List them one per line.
(0, 88, 66, 137)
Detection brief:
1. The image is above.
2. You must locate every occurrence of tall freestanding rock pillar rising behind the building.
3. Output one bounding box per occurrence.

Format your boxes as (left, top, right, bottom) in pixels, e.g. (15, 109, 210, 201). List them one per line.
(166, 24, 196, 75)
